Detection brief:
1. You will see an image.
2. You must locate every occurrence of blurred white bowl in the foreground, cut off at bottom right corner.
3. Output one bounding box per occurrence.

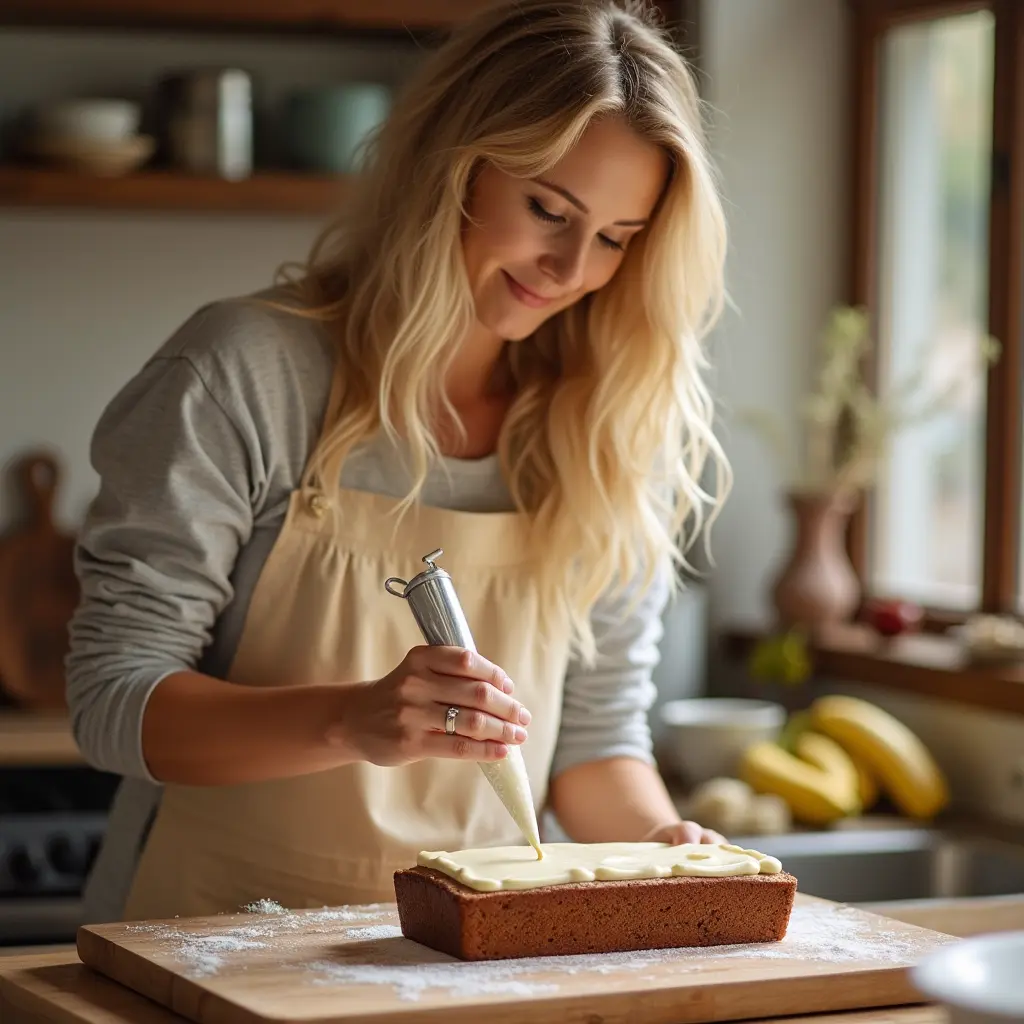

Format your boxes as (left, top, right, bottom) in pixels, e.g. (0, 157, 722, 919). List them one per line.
(910, 932, 1024, 1024)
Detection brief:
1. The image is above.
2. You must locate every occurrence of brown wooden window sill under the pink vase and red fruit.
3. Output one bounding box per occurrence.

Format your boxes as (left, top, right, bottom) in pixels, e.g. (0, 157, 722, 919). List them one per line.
(722, 625, 1024, 715)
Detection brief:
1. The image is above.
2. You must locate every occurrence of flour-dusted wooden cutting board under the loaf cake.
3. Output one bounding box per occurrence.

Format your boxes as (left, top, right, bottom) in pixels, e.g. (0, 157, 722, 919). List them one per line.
(78, 895, 955, 1024)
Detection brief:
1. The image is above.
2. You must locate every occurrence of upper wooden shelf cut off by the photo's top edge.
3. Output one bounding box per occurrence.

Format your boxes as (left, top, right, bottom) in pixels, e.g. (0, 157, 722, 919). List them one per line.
(0, 0, 487, 32)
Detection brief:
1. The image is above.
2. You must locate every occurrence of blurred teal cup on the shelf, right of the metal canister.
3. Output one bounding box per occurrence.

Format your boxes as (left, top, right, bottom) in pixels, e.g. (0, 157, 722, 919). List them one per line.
(283, 82, 391, 174)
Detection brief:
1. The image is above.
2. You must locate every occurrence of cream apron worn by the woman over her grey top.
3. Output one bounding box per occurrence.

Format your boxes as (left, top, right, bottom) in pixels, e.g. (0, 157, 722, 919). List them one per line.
(124, 411, 567, 921)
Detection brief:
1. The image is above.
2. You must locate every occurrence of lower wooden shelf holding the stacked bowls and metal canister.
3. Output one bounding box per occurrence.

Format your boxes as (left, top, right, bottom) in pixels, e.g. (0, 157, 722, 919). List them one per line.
(0, 166, 345, 214)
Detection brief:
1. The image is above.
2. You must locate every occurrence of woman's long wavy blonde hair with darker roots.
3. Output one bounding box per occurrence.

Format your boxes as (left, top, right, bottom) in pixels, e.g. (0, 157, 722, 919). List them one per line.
(276, 0, 731, 663)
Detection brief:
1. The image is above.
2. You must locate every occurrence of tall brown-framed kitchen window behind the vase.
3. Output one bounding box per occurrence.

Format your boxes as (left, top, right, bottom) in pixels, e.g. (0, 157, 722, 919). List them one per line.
(851, 0, 1024, 624)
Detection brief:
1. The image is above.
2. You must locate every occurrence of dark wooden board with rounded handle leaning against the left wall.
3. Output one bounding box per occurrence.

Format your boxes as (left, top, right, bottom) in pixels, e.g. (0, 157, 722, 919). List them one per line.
(0, 453, 79, 709)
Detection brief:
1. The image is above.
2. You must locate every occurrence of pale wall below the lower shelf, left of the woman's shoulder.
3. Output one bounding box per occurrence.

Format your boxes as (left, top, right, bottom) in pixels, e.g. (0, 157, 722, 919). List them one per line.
(0, 213, 312, 525)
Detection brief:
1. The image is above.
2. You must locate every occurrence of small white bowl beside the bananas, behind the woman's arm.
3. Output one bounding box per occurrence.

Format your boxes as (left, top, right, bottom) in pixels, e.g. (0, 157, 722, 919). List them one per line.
(660, 697, 786, 785)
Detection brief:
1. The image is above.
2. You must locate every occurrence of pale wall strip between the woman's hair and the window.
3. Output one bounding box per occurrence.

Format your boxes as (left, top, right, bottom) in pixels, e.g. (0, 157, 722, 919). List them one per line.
(701, 0, 849, 625)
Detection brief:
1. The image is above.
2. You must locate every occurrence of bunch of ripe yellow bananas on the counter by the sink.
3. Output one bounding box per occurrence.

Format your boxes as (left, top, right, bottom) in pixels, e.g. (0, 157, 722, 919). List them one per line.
(737, 695, 949, 824)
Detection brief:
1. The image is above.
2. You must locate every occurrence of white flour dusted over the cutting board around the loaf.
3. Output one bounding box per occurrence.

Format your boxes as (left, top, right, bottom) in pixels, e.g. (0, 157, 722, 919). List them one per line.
(127, 903, 954, 1000)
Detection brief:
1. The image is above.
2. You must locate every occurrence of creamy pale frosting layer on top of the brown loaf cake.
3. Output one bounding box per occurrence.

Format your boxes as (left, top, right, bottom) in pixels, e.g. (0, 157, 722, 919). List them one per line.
(417, 843, 782, 892)
